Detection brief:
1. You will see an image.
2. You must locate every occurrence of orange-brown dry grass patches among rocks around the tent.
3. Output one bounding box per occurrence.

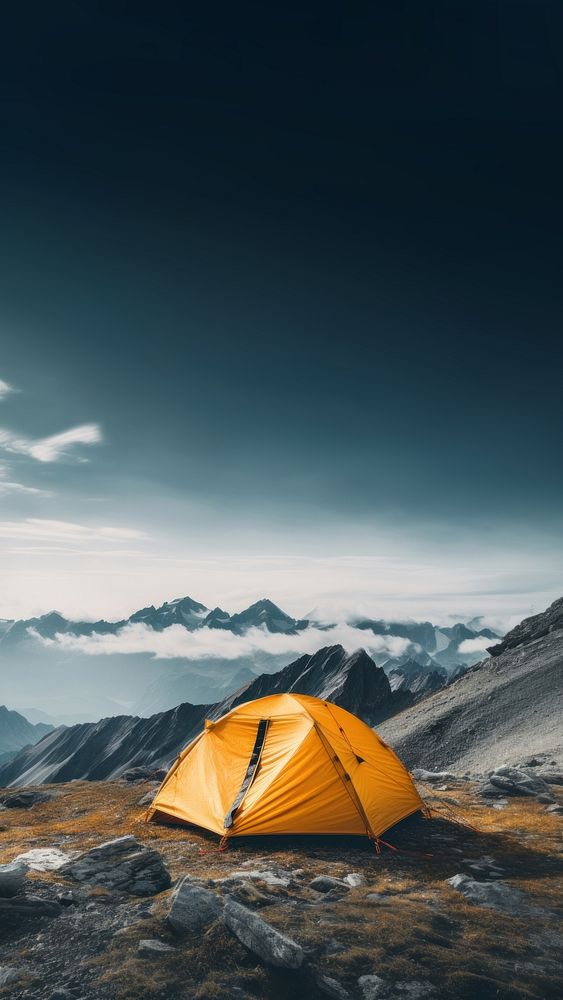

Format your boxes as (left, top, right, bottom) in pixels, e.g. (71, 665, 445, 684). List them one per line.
(0, 782, 563, 1000)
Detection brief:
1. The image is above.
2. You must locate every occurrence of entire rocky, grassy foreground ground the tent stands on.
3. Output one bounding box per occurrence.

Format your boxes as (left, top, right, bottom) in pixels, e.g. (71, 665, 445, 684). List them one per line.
(0, 759, 563, 1000)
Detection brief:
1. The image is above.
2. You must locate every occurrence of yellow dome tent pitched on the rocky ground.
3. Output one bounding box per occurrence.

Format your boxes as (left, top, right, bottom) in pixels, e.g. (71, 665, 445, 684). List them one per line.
(146, 694, 423, 841)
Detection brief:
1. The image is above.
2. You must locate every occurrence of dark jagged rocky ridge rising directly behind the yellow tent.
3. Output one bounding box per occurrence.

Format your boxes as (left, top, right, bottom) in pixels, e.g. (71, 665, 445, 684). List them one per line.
(0, 646, 409, 785)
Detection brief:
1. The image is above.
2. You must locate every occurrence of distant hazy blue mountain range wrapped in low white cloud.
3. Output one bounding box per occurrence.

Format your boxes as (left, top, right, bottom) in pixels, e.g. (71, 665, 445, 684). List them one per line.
(0, 597, 495, 724)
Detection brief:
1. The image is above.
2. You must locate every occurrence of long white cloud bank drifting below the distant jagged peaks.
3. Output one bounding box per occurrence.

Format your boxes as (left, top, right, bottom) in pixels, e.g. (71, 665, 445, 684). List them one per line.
(32, 622, 409, 662)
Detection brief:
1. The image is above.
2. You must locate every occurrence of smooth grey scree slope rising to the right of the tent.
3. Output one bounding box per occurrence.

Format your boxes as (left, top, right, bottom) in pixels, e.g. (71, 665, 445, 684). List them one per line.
(379, 599, 563, 772)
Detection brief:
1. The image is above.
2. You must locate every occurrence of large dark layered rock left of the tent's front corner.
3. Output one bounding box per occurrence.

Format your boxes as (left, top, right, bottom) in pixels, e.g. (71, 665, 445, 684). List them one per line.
(59, 835, 171, 896)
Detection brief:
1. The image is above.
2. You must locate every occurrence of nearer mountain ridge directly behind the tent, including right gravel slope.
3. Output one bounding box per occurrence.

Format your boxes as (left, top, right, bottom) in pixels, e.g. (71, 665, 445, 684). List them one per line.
(0, 599, 563, 785)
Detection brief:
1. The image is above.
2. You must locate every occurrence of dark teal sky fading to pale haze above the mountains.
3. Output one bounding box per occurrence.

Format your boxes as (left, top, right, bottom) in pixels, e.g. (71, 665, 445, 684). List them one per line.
(0, 0, 563, 622)
